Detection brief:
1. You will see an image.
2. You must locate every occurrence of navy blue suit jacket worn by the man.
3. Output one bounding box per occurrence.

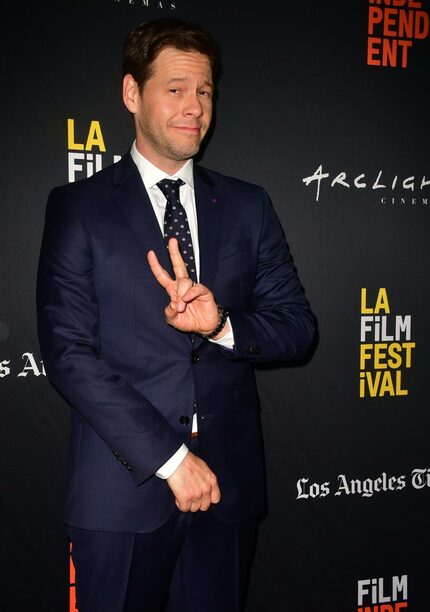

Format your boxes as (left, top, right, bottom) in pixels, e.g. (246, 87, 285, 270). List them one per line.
(38, 154, 314, 532)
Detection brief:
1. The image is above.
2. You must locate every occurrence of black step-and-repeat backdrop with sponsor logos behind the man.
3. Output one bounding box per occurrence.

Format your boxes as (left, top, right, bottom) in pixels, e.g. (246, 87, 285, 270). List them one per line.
(0, 0, 430, 612)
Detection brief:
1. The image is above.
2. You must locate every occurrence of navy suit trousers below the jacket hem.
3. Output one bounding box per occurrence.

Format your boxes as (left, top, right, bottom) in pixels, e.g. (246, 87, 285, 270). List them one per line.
(68, 507, 256, 612)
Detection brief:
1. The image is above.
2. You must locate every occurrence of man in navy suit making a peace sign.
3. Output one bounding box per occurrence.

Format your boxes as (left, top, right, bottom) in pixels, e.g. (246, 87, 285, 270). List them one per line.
(38, 19, 314, 612)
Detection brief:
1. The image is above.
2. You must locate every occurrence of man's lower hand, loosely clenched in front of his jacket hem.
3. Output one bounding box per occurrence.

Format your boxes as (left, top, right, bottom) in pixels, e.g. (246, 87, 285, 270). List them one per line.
(167, 452, 221, 512)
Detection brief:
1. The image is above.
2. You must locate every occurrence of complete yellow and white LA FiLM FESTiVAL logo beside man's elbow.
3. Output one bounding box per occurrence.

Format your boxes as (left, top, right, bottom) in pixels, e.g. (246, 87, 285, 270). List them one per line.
(359, 288, 416, 398)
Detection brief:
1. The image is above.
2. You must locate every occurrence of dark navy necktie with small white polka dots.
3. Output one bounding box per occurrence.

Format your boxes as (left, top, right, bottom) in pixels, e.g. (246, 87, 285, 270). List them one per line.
(157, 179, 197, 281)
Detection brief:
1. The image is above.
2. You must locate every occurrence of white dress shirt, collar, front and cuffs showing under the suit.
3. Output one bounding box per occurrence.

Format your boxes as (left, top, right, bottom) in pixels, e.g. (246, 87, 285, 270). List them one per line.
(130, 141, 234, 479)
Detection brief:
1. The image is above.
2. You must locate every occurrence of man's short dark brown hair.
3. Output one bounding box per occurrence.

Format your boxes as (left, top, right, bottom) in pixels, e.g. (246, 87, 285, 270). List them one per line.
(122, 18, 221, 91)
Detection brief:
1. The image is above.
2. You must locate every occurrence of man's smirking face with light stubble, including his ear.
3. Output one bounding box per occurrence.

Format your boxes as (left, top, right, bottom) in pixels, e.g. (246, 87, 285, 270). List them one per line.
(123, 47, 213, 174)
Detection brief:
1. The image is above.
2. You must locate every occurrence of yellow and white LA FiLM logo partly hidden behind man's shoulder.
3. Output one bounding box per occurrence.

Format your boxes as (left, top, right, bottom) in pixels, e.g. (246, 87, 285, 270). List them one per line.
(67, 118, 121, 183)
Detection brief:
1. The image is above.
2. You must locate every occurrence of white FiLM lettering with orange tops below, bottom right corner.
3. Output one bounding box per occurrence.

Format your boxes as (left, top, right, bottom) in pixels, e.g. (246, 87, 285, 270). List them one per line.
(357, 574, 408, 612)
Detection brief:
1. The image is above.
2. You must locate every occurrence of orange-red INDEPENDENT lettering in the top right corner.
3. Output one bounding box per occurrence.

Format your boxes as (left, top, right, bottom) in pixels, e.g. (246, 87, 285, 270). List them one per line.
(367, 0, 429, 68)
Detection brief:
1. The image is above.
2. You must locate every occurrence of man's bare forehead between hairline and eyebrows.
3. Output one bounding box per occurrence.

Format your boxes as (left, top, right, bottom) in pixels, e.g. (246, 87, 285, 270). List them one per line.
(151, 47, 212, 83)
